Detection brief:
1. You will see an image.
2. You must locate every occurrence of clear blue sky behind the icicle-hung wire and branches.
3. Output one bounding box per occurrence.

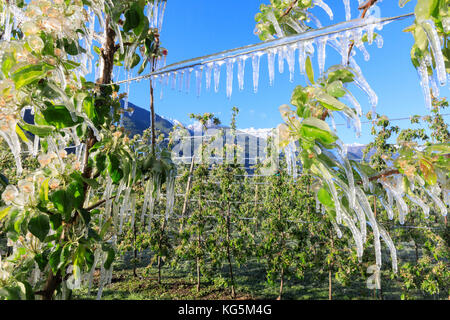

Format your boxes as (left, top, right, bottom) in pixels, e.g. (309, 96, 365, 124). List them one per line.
(118, 0, 449, 143)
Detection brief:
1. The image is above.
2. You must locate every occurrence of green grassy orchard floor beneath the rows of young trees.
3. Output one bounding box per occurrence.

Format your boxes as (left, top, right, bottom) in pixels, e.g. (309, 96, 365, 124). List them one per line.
(73, 246, 438, 300)
